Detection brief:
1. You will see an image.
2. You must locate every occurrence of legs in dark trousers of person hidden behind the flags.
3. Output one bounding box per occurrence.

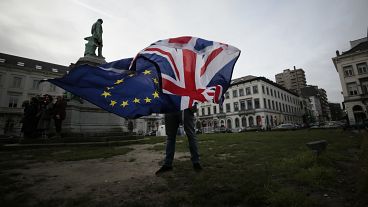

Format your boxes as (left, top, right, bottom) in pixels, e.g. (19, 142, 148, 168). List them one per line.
(156, 107, 202, 175)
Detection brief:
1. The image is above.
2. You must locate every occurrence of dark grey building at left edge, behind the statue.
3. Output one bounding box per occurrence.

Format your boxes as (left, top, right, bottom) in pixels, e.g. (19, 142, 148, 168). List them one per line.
(0, 53, 68, 135)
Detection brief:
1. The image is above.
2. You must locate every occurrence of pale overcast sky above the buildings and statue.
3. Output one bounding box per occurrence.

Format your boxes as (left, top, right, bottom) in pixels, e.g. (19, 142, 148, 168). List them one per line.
(0, 0, 368, 102)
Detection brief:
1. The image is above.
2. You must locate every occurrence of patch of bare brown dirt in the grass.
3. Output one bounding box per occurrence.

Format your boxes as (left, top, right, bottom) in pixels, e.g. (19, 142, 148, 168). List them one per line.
(9, 144, 190, 206)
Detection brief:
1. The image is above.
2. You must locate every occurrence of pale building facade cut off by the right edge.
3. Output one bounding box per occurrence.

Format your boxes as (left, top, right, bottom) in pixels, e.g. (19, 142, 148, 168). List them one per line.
(332, 37, 368, 125)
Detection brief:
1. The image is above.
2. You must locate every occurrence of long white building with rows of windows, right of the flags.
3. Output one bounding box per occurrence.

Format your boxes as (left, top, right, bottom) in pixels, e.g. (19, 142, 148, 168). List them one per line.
(196, 76, 303, 132)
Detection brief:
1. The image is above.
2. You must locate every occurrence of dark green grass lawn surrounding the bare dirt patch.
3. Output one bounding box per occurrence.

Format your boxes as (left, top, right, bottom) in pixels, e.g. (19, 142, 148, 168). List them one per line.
(0, 129, 368, 207)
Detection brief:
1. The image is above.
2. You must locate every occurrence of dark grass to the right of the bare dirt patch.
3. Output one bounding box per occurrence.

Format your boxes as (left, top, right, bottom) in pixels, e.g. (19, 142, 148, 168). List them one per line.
(148, 130, 368, 206)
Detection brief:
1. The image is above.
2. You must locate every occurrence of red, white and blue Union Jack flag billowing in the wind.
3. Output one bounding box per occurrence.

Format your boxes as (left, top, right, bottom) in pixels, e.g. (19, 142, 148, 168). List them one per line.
(138, 36, 240, 110)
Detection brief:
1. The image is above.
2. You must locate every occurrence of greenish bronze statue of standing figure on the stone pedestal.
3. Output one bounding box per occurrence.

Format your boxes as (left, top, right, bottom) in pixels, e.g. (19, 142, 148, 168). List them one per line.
(84, 19, 103, 58)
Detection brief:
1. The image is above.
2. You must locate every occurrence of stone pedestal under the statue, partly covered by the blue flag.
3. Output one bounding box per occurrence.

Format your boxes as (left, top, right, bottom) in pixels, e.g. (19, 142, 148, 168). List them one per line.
(63, 56, 127, 136)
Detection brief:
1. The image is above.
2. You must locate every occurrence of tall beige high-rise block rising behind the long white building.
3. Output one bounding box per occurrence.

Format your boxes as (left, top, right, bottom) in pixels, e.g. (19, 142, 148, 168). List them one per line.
(275, 66, 307, 94)
